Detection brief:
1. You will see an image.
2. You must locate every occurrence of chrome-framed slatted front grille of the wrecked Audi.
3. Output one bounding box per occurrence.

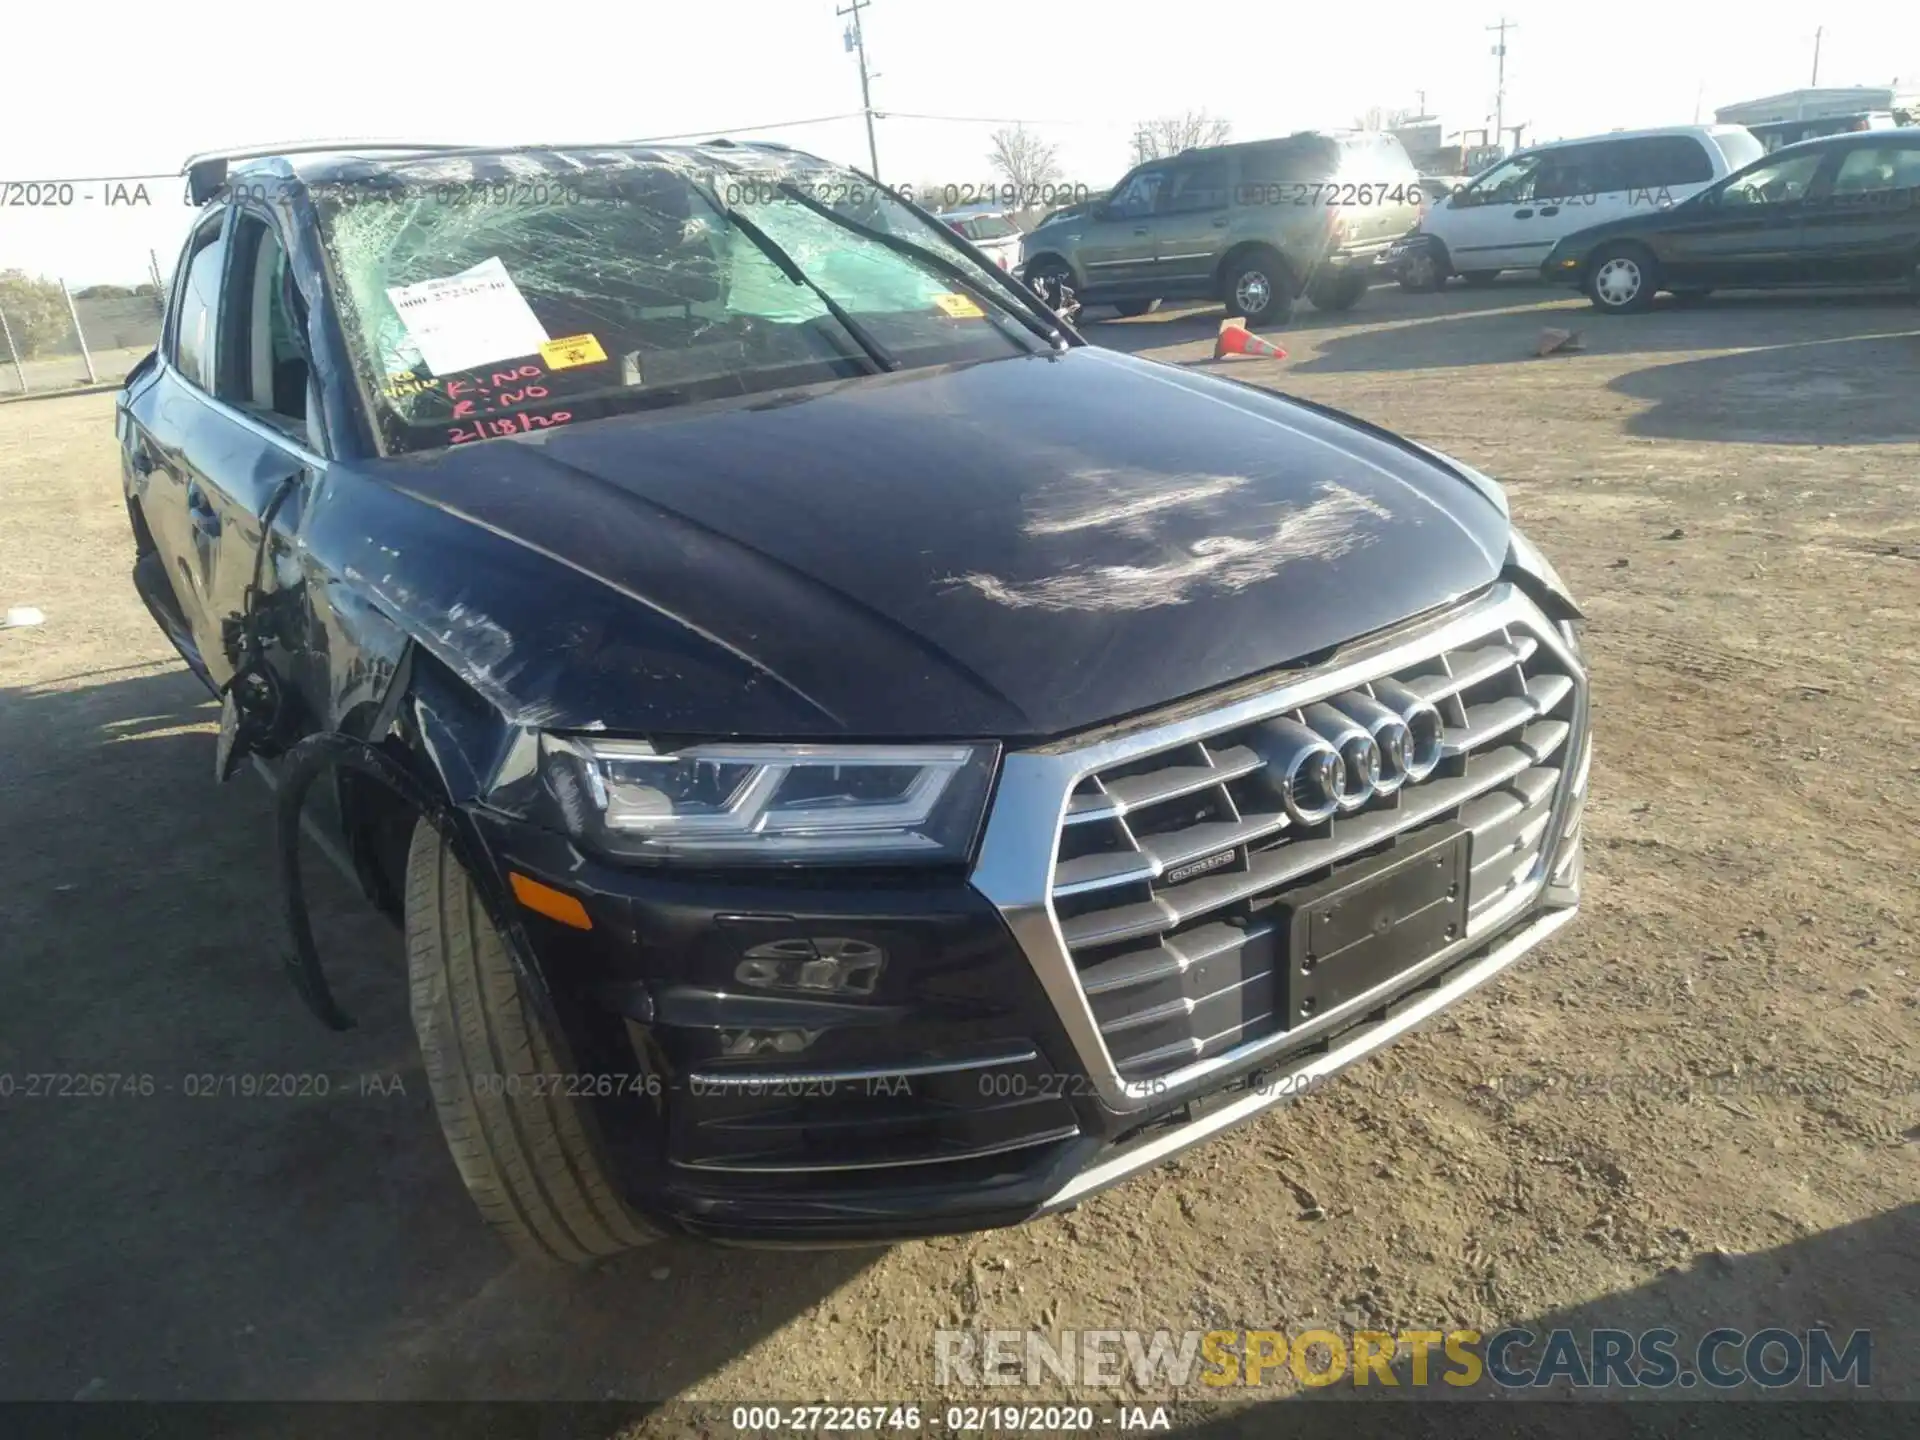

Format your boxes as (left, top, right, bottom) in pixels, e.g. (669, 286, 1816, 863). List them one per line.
(977, 586, 1586, 1108)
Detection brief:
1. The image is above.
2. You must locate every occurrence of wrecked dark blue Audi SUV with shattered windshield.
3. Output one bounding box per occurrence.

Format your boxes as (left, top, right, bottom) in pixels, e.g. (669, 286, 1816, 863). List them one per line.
(117, 144, 1590, 1261)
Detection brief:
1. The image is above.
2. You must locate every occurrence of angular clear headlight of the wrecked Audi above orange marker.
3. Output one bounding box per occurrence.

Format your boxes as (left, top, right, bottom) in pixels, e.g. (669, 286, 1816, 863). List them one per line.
(541, 735, 998, 864)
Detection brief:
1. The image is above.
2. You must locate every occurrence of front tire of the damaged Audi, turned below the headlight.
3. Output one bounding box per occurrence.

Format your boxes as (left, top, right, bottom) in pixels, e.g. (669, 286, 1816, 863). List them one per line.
(407, 820, 659, 1265)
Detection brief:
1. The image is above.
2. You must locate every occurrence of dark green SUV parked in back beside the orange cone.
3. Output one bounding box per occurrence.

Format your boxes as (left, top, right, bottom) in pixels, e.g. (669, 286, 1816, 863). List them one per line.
(1021, 132, 1421, 326)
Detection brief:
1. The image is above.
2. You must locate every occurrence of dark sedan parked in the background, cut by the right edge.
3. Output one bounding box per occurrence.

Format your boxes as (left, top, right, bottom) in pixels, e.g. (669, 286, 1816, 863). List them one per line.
(1542, 129, 1920, 315)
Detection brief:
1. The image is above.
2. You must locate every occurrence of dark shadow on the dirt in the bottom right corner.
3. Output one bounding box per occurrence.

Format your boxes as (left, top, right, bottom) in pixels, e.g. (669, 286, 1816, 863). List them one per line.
(1181, 1204, 1920, 1440)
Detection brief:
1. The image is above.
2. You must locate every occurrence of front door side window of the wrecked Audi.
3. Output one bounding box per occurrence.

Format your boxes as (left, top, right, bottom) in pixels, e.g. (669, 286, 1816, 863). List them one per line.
(213, 213, 307, 434)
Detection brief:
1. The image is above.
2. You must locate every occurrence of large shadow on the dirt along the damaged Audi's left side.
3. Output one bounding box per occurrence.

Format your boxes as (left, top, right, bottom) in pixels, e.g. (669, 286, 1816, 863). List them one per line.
(0, 670, 879, 1400)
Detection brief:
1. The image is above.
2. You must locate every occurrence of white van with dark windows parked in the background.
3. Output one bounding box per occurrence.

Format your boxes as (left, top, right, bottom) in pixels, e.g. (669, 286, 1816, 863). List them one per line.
(1396, 125, 1766, 290)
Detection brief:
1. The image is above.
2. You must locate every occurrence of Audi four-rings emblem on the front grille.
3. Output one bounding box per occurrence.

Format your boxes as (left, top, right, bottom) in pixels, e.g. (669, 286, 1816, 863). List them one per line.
(1256, 680, 1444, 826)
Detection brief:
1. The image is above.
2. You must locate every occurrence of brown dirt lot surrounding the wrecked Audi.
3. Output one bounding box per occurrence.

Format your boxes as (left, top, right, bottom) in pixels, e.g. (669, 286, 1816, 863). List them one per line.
(0, 284, 1920, 1400)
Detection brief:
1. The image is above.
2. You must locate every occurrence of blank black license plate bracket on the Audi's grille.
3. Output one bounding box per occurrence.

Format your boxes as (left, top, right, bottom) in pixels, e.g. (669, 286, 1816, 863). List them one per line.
(1275, 822, 1473, 1029)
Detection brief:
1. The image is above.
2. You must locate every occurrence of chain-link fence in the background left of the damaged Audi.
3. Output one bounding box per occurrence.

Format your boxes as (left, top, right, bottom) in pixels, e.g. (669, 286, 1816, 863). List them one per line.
(0, 263, 167, 396)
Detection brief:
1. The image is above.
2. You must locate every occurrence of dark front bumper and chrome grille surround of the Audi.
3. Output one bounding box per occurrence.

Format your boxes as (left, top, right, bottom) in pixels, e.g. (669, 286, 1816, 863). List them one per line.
(478, 588, 1588, 1244)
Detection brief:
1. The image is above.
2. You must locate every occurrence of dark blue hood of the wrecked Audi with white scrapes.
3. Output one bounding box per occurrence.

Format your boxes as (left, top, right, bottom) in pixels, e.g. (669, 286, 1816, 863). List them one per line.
(330, 348, 1507, 741)
